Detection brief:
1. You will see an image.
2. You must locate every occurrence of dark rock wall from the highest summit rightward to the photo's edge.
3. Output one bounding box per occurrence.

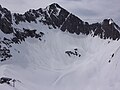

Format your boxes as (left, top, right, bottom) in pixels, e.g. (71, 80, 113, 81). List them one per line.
(42, 3, 120, 40)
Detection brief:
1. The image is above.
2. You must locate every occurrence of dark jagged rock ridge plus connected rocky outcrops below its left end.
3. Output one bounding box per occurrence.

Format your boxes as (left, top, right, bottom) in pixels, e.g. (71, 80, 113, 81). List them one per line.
(0, 3, 120, 61)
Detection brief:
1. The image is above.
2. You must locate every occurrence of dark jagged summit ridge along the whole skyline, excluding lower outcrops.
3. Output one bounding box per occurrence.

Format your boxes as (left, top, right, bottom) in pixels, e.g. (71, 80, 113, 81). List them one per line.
(0, 3, 120, 40)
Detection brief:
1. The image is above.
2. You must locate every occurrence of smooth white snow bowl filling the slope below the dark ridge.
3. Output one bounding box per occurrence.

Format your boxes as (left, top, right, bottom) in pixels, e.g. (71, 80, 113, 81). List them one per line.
(0, 22, 120, 90)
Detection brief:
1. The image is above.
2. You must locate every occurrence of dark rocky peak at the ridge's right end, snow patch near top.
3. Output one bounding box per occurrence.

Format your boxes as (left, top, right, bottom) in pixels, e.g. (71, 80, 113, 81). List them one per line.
(90, 19, 120, 40)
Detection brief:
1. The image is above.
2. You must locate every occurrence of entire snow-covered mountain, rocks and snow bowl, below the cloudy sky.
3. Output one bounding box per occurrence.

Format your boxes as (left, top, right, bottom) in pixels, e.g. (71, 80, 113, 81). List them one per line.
(0, 3, 120, 90)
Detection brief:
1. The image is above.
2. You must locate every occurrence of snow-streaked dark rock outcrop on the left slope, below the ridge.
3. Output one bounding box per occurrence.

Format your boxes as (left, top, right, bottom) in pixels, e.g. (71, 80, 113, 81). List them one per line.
(0, 28, 44, 62)
